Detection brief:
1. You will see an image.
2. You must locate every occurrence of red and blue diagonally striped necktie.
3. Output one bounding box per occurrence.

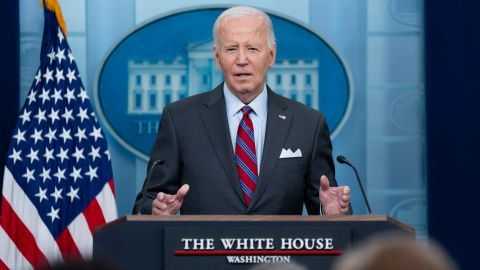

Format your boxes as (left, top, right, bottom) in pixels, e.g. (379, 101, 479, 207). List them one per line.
(235, 106, 258, 205)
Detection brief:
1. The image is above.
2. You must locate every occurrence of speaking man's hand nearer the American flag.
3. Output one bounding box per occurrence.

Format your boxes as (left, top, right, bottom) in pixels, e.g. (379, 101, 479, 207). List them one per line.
(152, 184, 190, 215)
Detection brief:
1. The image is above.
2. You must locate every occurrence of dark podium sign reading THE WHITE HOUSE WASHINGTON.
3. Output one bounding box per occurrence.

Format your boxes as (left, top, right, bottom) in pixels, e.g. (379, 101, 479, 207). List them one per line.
(164, 226, 350, 269)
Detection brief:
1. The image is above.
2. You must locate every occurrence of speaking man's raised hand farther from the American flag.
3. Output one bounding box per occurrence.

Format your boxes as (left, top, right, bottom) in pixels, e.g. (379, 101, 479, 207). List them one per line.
(319, 175, 350, 215)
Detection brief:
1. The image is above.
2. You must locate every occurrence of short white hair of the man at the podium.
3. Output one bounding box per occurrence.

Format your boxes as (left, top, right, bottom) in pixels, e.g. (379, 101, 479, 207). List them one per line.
(213, 6, 275, 48)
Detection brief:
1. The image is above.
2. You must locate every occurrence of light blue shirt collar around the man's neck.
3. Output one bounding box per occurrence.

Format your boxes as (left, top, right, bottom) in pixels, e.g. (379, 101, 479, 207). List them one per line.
(223, 83, 268, 121)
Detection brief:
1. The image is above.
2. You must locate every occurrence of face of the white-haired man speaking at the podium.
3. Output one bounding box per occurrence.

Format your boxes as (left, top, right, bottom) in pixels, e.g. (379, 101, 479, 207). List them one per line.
(214, 16, 276, 103)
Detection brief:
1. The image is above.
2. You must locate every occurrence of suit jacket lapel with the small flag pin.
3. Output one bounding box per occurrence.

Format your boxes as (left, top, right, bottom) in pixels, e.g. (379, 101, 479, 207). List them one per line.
(249, 88, 292, 210)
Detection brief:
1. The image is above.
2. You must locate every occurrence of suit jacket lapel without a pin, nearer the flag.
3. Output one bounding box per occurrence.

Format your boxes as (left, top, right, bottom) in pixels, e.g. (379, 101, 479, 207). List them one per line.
(200, 84, 244, 206)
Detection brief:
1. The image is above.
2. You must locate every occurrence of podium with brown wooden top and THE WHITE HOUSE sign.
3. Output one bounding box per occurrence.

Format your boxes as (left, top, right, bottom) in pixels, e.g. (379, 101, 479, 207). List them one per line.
(93, 215, 415, 270)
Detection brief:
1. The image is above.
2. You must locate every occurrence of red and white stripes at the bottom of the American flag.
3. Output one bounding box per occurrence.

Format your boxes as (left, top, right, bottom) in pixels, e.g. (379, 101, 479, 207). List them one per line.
(0, 168, 117, 270)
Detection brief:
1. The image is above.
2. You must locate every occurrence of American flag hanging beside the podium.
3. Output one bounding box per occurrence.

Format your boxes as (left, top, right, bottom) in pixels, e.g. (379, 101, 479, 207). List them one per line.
(0, 3, 117, 269)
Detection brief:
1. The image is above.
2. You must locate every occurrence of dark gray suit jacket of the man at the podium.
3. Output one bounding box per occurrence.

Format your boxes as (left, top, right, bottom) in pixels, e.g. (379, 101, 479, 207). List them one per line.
(133, 84, 337, 214)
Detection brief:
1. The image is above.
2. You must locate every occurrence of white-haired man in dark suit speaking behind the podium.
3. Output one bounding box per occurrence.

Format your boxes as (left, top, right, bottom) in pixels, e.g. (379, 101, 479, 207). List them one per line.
(133, 7, 350, 215)
